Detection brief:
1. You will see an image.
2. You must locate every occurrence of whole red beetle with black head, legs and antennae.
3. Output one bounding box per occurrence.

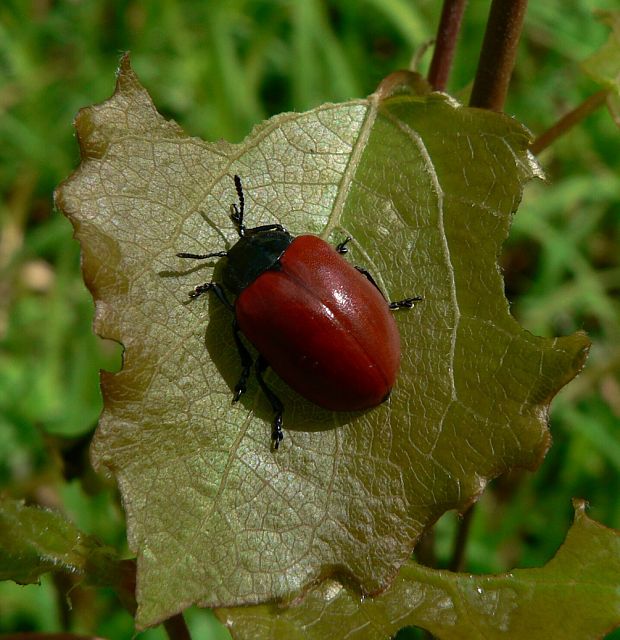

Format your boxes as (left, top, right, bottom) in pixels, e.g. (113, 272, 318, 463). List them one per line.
(177, 176, 421, 449)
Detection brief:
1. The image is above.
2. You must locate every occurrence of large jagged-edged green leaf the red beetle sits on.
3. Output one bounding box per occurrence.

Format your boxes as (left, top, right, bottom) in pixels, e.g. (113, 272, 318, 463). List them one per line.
(57, 58, 589, 626)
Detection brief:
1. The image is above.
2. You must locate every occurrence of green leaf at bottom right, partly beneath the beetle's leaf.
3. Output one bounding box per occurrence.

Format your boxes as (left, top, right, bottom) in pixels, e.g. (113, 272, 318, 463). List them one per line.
(216, 501, 620, 640)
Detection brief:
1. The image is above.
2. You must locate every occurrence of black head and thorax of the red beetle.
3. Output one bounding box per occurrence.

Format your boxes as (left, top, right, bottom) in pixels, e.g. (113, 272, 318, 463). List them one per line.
(222, 229, 293, 295)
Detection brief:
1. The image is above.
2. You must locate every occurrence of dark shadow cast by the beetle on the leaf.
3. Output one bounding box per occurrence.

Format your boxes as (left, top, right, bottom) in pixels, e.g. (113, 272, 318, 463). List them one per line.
(204, 296, 365, 438)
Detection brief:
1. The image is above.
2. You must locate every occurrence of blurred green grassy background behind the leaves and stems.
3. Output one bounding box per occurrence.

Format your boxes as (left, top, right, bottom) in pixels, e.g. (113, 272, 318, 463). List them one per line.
(0, 0, 620, 640)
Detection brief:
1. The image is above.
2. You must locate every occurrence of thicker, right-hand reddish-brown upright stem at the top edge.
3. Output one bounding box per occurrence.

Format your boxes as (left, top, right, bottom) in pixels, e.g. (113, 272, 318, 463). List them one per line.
(469, 0, 527, 111)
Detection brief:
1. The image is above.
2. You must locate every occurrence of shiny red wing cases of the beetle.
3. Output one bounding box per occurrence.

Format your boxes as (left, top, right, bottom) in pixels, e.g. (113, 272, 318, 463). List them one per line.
(235, 235, 400, 411)
